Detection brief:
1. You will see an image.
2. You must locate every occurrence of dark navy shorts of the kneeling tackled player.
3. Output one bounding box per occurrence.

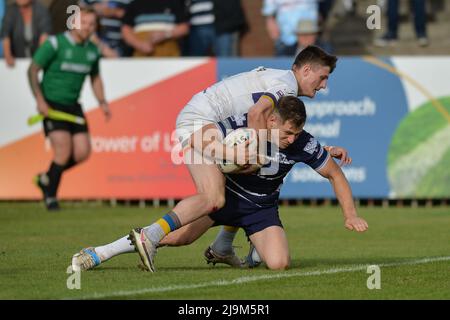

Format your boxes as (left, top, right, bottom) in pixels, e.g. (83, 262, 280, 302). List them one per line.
(209, 189, 283, 237)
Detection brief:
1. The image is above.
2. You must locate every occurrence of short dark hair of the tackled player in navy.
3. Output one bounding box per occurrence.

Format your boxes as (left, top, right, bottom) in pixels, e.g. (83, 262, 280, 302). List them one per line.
(274, 96, 306, 128)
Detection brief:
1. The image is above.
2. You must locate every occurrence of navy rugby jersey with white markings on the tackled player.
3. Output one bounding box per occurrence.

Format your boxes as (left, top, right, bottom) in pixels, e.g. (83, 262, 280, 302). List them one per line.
(216, 114, 330, 205)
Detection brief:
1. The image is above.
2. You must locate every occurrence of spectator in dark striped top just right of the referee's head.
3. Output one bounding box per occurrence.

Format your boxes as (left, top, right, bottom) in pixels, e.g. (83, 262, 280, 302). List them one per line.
(80, 0, 133, 57)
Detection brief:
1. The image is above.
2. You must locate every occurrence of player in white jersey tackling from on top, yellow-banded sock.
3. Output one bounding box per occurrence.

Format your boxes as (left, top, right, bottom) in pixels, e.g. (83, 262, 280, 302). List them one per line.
(73, 46, 337, 271)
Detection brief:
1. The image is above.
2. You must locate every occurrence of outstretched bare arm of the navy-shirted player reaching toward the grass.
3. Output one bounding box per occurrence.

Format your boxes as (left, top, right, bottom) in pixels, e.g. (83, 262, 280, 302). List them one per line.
(318, 159, 368, 232)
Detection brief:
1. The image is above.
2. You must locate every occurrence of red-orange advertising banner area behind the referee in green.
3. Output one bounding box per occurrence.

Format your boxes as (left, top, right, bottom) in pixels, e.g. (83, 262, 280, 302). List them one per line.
(0, 59, 217, 199)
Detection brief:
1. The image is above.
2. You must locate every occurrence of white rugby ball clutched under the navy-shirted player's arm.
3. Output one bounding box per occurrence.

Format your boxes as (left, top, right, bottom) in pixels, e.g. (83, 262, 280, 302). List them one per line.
(218, 128, 261, 173)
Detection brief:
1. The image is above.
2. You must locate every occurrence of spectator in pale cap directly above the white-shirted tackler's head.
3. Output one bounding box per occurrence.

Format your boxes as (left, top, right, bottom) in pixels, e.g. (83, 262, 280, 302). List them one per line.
(296, 19, 334, 55)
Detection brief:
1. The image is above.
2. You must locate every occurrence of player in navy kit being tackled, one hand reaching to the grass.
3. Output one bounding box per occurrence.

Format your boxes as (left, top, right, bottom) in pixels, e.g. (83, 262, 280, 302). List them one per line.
(72, 96, 368, 270)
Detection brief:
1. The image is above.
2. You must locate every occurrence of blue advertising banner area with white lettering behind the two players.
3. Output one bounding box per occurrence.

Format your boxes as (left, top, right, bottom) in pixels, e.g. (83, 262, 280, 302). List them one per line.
(217, 57, 428, 198)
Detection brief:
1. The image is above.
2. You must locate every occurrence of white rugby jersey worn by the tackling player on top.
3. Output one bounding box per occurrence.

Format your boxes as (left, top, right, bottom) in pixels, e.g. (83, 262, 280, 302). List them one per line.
(180, 67, 298, 122)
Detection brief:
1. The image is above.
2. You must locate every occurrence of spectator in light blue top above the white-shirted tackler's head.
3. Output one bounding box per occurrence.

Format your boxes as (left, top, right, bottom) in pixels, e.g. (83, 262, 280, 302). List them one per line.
(262, 0, 319, 56)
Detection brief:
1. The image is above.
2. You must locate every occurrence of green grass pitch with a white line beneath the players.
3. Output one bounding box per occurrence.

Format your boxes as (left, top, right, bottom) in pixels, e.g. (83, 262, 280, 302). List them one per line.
(0, 203, 450, 300)
